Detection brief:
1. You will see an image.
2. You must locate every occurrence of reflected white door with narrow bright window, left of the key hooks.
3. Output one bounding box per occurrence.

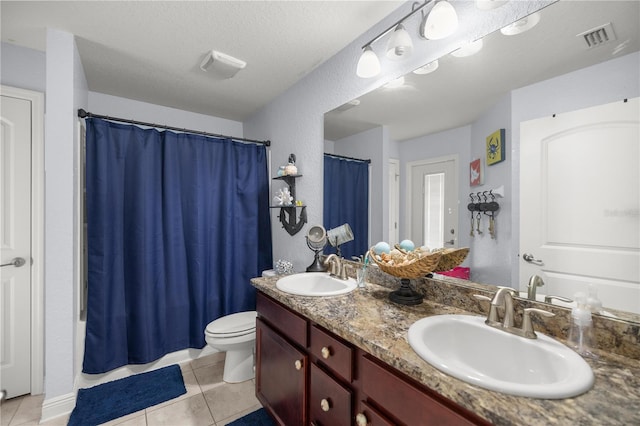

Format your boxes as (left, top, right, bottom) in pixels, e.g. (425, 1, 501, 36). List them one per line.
(407, 156, 458, 249)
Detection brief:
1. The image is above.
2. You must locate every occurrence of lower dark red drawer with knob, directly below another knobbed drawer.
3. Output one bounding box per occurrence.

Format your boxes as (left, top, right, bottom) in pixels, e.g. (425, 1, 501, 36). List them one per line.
(309, 364, 351, 426)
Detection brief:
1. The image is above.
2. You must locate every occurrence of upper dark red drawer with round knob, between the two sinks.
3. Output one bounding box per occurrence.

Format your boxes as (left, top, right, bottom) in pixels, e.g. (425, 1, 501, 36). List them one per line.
(310, 325, 354, 383)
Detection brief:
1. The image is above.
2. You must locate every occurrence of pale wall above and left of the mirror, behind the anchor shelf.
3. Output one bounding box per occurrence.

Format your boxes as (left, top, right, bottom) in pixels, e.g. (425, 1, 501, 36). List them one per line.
(245, 1, 551, 271)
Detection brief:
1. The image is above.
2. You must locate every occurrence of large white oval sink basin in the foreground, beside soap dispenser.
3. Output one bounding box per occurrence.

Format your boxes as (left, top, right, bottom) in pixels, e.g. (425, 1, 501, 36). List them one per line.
(408, 315, 593, 399)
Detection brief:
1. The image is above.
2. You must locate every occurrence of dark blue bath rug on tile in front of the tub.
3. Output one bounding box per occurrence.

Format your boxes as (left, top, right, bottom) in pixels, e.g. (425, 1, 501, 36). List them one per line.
(67, 365, 187, 426)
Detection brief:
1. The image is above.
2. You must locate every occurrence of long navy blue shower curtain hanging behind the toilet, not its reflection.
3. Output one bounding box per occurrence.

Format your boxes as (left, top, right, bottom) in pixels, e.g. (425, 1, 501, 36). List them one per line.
(83, 118, 272, 373)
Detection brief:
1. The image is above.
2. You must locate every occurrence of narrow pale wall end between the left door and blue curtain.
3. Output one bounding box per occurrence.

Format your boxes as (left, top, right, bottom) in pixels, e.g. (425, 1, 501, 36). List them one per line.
(45, 30, 86, 403)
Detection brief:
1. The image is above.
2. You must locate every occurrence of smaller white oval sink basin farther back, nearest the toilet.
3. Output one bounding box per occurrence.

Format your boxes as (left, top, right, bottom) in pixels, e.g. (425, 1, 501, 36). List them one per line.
(276, 272, 357, 296)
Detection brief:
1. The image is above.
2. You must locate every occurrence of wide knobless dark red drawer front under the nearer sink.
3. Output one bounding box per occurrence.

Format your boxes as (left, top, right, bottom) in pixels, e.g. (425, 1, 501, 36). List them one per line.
(359, 356, 486, 426)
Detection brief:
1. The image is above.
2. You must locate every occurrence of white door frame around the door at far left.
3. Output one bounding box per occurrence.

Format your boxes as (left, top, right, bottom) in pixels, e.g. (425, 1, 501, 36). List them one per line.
(0, 85, 44, 395)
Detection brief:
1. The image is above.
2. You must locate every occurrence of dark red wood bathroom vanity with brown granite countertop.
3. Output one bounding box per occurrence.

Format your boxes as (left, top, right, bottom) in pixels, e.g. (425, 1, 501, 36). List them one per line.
(251, 277, 640, 426)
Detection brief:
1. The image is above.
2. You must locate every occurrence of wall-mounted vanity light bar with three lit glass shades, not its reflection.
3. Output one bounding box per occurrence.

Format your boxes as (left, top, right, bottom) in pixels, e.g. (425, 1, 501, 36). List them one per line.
(356, 0, 458, 78)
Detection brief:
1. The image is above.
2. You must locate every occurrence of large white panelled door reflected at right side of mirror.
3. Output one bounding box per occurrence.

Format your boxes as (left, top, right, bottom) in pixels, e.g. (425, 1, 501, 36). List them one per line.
(520, 98, 640, 312)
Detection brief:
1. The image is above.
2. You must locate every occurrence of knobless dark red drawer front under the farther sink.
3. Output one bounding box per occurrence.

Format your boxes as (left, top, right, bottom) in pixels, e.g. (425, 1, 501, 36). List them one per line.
(256, 292, 308, 348)
